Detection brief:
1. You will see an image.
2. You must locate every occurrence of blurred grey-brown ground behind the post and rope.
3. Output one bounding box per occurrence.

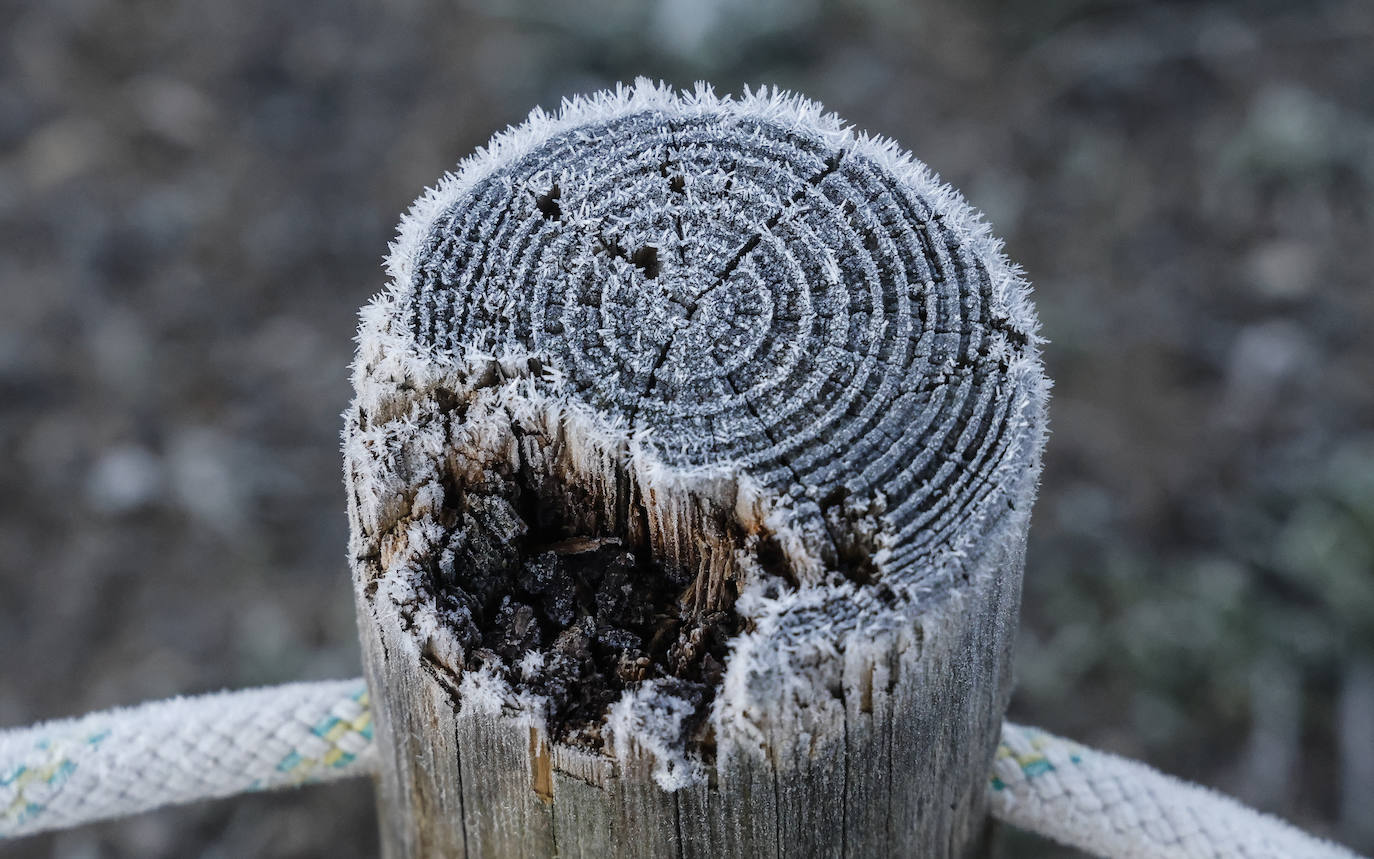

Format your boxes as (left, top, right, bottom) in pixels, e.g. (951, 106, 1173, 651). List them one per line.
(0, 0, 1374, 858)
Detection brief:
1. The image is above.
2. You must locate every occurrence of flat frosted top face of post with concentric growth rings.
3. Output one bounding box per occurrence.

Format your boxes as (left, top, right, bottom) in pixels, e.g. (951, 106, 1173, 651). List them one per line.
(405, 109, 1037, 571)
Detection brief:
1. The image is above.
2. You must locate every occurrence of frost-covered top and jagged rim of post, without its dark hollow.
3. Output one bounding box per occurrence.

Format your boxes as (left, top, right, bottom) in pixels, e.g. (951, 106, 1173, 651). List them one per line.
(345, 81, 1047, 788)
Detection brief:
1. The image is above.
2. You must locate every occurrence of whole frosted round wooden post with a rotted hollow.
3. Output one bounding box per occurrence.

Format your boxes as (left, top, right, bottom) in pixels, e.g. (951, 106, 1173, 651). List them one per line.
(344, 81, 1047, 856)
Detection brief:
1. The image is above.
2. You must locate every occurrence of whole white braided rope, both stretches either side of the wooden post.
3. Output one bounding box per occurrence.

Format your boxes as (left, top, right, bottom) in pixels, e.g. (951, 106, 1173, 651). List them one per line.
(0, 680, 1356, 859)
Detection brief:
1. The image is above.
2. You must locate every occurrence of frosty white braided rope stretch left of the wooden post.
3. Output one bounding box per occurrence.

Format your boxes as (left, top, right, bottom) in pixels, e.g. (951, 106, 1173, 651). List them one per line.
(0, 679, 376, 840)
